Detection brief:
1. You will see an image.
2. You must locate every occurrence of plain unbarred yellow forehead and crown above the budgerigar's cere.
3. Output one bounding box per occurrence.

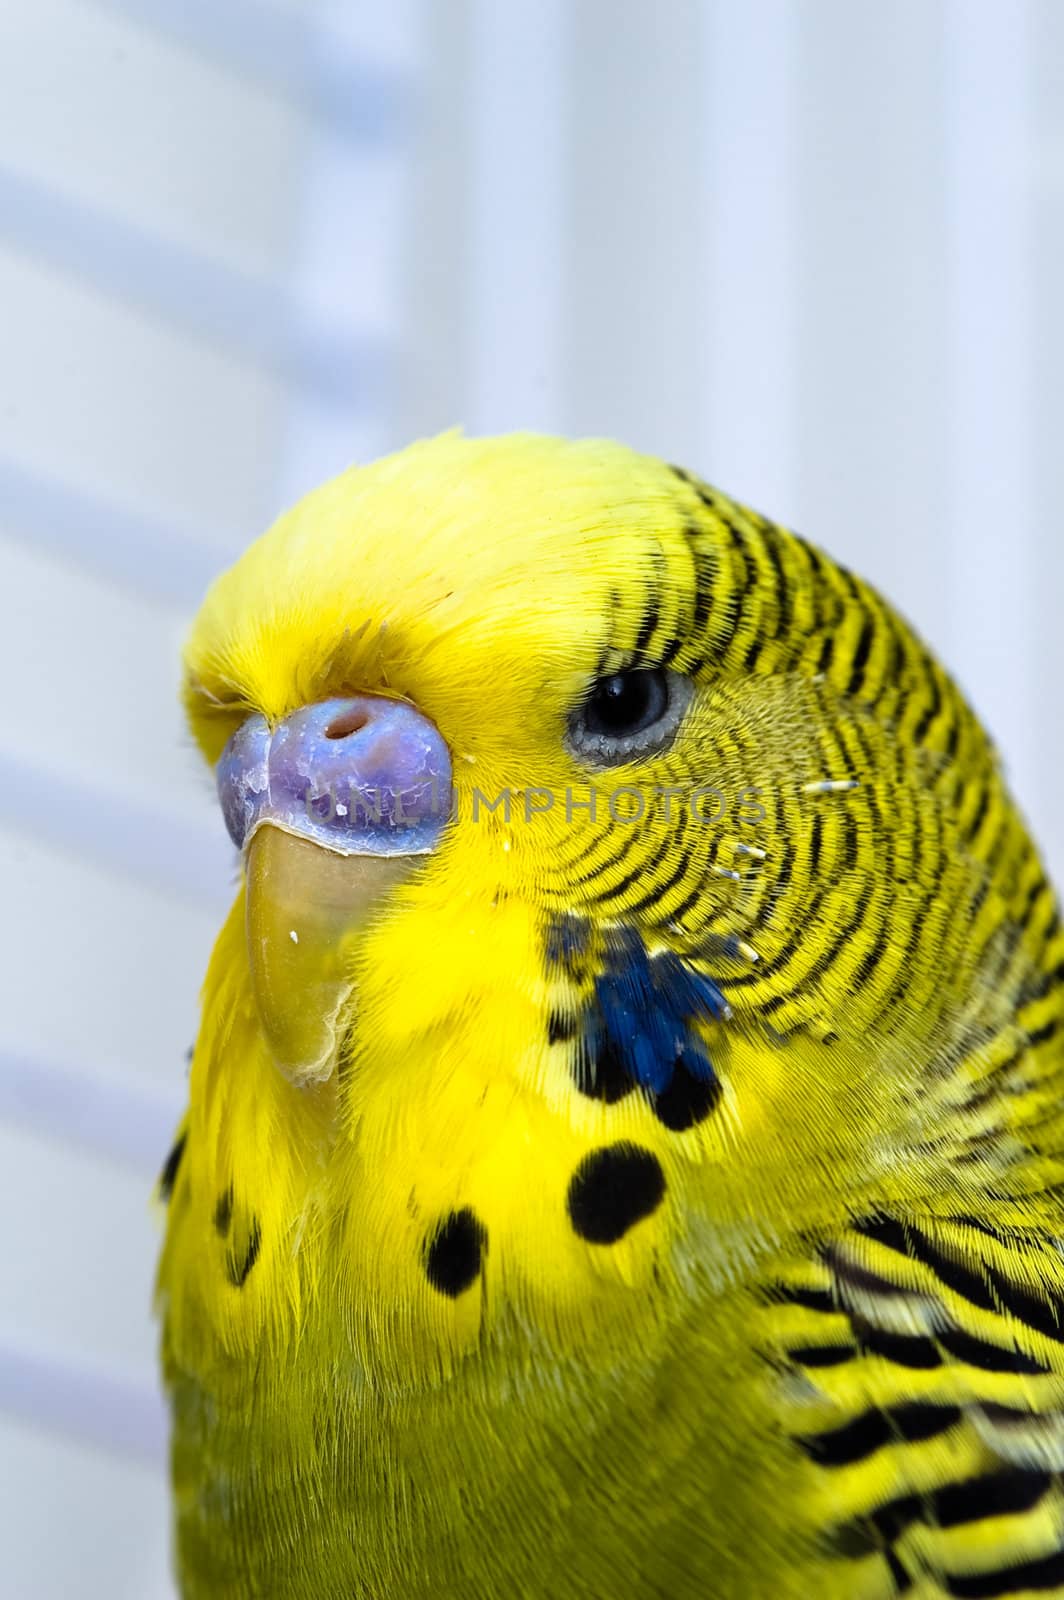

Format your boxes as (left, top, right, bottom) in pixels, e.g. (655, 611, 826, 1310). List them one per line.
(186, 434, 677, 755)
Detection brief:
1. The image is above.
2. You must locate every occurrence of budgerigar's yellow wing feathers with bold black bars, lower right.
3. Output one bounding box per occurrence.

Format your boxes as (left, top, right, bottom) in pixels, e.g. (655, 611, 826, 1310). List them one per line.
(768, 1214, 1064, 1600)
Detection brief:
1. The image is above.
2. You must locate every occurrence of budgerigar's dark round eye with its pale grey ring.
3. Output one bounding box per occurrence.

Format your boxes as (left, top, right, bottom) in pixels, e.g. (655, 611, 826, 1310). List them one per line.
(568, 667, 691, 766)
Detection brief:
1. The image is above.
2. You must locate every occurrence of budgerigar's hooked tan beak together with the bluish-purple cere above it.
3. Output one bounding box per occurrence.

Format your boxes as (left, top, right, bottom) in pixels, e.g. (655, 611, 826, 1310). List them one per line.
(218, 694, 451, 1083)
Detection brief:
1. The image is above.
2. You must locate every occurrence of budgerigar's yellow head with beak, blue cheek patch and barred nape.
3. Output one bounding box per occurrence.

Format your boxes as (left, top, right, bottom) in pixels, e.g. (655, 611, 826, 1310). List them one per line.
(186, 434, 1024, 1299)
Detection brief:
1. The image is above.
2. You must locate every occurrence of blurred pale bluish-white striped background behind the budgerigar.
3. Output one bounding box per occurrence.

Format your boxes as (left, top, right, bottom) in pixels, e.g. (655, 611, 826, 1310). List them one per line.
(0, 0, 1064, 1600)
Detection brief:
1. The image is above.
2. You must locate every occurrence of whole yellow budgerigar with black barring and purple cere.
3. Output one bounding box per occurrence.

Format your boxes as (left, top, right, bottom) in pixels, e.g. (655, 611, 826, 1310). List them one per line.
(158, 434, 1064, 1600)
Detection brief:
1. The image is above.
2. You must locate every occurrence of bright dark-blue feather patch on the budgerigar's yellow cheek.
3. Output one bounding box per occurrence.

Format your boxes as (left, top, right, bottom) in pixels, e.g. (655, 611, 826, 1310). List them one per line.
(586, 928, 731, 1094)
